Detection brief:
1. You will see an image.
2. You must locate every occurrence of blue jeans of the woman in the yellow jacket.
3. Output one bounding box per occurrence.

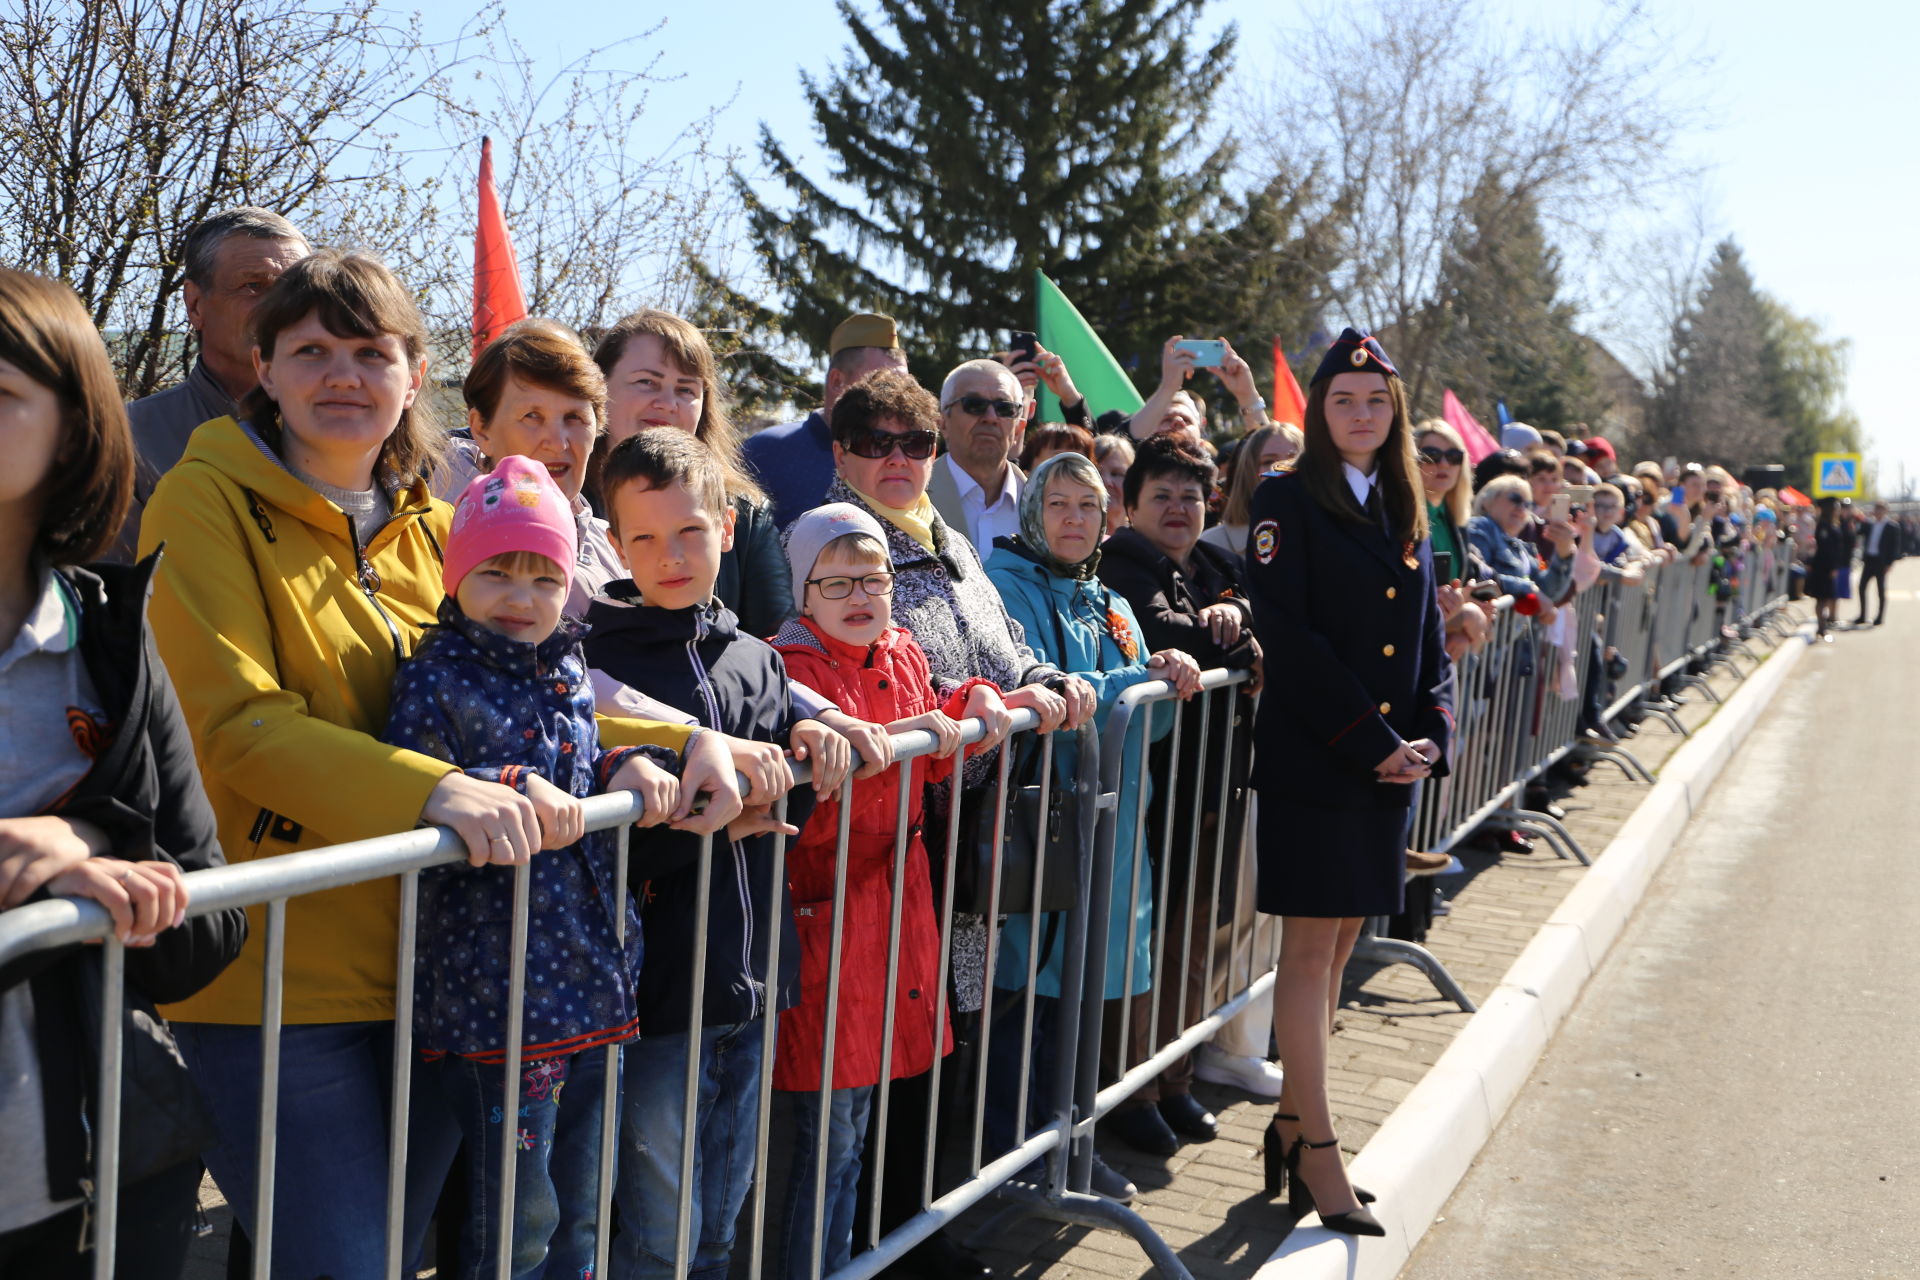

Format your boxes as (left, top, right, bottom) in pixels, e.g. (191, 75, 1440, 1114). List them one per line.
(173, 1023, 459, 1280)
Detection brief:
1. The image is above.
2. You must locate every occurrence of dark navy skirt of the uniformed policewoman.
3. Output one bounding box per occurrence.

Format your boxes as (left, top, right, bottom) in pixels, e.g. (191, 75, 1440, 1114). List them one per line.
(1254, 793, 1413, 915)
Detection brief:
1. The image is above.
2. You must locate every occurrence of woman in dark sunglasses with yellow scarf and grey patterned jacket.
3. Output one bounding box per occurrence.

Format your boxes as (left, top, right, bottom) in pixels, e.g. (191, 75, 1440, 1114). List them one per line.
(826, 368, 1096, 1274)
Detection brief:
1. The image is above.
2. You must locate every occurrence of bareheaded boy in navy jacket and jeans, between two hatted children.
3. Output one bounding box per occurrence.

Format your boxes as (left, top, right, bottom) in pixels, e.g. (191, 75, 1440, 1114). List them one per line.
(586, 430, 812, 1280)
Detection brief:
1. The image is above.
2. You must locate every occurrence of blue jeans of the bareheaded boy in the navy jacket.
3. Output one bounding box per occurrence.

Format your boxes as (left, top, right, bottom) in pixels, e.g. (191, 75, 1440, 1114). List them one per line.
(612, 1019, 764, 1280)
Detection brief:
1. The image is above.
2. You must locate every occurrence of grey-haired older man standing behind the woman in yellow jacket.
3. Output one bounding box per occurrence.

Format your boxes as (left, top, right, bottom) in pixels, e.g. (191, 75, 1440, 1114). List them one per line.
(115, 205, 309, 560)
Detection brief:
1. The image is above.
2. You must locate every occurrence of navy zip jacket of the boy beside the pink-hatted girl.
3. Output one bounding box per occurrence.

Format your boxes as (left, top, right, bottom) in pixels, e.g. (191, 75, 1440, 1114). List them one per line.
(584, 578, 814, 1036)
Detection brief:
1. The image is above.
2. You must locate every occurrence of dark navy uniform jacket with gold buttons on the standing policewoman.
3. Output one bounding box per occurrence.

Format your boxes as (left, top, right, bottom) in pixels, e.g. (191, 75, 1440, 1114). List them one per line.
(1246, 472, 1453, 808)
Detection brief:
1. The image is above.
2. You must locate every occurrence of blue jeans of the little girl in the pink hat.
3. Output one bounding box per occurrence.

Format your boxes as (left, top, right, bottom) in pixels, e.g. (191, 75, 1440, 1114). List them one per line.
(433, 1050, 607, 1280)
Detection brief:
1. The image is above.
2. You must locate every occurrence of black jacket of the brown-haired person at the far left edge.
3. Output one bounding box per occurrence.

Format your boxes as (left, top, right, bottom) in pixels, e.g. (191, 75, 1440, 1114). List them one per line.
(0, 555, 246, 1199)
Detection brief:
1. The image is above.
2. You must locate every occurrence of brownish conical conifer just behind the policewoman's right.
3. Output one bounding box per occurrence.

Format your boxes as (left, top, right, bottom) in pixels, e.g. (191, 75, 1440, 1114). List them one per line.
(1423, 175, 1607, 430)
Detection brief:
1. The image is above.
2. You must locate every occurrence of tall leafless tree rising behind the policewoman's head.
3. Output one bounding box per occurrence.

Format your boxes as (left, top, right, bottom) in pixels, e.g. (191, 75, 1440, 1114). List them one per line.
(1250, 0, 1701, 399)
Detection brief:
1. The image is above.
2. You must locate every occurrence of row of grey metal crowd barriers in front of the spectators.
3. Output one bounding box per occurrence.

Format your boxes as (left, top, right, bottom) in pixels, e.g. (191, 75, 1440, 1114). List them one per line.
(0, 537, 1786, 1280)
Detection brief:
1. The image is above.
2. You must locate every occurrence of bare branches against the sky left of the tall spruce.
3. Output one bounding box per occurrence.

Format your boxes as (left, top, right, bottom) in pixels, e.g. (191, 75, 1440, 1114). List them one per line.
(0, 0, 737, 395)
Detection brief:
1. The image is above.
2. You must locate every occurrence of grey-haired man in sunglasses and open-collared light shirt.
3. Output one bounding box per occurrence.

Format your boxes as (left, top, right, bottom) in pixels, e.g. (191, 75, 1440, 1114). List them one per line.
(927, 361, 1033, 560)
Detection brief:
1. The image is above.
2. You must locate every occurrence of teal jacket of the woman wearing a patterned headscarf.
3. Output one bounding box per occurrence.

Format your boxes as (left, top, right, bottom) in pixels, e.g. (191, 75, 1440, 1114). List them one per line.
(987, 537, 1173, 1000)
